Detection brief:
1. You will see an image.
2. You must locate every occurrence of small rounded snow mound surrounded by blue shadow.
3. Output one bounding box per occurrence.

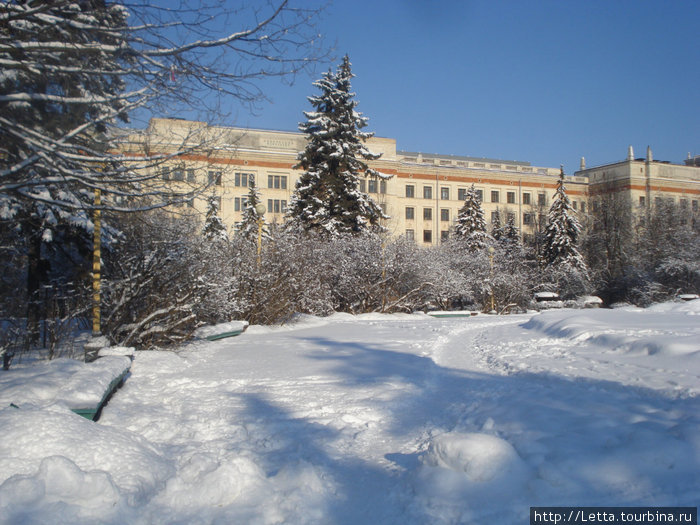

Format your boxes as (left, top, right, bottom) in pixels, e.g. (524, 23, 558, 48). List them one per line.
(423, 433, 524, 483)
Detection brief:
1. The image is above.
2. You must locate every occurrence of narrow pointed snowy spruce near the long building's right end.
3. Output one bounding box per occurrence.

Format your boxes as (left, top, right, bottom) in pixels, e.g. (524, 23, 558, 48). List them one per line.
(542, 168, 586, 270)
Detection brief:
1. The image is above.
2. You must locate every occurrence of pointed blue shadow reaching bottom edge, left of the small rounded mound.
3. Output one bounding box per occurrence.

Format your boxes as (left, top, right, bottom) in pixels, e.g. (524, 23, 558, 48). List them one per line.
(231, 393, 430, 525)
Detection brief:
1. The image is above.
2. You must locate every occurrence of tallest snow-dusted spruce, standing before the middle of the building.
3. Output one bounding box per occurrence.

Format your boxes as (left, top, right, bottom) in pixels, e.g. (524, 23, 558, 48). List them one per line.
(287, 55, 389, 237)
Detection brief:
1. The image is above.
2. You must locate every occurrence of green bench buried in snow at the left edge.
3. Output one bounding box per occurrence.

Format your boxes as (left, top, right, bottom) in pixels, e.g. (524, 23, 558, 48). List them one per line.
(0, 349, 131, 420)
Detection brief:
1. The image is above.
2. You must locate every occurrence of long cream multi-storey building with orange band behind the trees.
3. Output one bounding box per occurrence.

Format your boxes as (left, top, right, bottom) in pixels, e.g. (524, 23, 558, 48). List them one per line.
(122, 119, 700, 242)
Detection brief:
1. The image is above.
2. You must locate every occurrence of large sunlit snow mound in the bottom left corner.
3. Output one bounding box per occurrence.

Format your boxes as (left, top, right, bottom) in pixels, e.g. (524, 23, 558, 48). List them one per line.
(0, 405, 174, 508)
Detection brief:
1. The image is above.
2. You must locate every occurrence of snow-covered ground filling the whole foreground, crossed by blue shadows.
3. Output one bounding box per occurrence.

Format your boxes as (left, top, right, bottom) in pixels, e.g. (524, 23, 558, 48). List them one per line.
(0, 301, 700, 524)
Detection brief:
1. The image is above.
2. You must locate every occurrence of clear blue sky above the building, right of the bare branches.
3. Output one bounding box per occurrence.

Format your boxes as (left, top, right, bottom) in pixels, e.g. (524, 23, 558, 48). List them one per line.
(231, 0, 700, 173)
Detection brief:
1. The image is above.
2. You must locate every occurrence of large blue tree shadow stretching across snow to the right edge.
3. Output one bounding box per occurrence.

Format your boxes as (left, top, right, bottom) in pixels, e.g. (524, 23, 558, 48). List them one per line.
(304, 338, 700, 506)
